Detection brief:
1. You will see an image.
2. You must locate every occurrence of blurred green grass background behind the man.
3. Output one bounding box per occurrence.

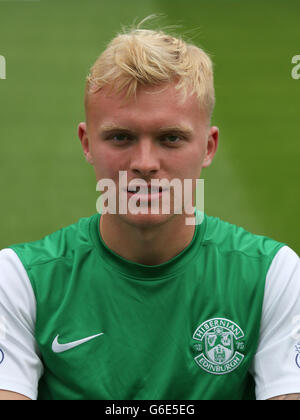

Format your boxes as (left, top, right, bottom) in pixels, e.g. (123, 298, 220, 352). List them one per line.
(0, 0, 300, 254)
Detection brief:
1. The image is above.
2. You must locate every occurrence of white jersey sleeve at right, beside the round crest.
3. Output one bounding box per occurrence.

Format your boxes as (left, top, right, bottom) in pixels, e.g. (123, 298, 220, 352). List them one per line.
(251, 246, 300, 400)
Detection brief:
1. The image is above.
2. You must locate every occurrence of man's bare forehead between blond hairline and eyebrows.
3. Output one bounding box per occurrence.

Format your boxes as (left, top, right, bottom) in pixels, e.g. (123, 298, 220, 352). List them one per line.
(86, 84, 208, 129)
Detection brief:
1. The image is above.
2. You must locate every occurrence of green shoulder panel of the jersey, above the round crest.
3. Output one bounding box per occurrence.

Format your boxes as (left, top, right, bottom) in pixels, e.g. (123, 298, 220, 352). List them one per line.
(203, 215, 285, 260)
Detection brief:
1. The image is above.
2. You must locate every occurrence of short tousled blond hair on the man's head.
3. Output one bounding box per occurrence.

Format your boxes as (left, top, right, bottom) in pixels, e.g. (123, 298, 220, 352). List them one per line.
(85, 18, 215, 116)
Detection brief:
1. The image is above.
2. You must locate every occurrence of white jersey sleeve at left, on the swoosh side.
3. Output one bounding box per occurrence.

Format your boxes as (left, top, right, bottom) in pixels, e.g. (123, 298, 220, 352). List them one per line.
(0, 249, 43, 400)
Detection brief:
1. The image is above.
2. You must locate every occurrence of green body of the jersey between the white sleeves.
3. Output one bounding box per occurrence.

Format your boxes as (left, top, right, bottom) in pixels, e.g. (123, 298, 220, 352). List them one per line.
(0, 214, 298, 400)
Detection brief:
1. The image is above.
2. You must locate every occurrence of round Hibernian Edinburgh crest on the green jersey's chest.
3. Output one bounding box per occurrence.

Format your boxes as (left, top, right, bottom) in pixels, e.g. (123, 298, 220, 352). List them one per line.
(193, 318, 245, 375)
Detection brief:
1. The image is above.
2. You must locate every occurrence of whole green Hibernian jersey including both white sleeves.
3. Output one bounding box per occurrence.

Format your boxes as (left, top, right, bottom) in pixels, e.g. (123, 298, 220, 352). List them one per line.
(0, 214, 300, 400)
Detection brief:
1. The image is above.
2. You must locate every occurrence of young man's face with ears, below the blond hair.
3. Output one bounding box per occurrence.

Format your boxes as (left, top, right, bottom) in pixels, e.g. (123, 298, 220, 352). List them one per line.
(78, 84, 218, 227)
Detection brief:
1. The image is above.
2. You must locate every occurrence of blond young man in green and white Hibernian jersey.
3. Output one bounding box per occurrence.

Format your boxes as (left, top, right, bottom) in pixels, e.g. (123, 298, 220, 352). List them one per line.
(0, 23, 300, 400)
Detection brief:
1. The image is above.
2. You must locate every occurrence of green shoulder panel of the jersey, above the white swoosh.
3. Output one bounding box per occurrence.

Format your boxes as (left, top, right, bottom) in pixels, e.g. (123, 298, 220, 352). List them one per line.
(9, 214, 98, 268)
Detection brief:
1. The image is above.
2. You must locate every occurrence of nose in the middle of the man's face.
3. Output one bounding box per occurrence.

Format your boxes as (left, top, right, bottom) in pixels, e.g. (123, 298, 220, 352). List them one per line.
(130, 139, 160, 177)
